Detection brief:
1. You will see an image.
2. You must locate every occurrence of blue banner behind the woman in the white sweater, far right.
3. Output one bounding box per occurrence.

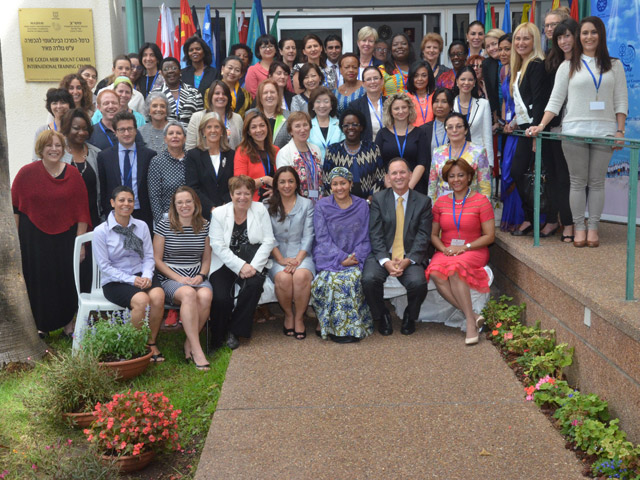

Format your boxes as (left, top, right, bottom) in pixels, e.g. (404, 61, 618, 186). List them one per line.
(592, 0, 640, 222)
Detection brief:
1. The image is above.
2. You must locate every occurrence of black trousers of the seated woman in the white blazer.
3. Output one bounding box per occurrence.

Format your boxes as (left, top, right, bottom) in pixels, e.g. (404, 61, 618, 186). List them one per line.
(209, 266, 265, 347)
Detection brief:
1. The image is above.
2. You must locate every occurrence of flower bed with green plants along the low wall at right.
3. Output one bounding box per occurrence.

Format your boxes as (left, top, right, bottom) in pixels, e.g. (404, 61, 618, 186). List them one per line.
(483, 296, 640, 480)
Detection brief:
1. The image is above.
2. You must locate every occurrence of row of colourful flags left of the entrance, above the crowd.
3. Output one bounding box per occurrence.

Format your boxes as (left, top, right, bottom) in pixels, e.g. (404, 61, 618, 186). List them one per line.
(156, 0, 280, 68)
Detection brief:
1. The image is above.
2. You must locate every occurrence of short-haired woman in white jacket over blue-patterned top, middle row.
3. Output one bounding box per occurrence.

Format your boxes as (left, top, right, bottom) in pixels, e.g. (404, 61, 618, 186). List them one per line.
(276, 112, 323, 205)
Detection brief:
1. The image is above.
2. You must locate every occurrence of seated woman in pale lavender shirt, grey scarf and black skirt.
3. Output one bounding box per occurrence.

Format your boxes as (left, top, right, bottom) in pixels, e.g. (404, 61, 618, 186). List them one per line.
(91, 185, 164, 362)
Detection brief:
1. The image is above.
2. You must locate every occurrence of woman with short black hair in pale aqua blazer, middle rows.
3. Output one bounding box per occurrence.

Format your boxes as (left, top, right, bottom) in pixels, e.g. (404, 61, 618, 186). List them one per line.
(309, 87, 344, 159)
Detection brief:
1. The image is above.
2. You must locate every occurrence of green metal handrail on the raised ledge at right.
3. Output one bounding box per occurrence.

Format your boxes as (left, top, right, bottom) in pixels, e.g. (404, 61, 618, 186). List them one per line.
(504, 130, 640, 301)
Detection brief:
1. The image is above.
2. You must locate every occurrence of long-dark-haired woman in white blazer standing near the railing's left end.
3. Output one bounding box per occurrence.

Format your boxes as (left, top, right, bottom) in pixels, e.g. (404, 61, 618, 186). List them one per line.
(453, 67, 494, 168)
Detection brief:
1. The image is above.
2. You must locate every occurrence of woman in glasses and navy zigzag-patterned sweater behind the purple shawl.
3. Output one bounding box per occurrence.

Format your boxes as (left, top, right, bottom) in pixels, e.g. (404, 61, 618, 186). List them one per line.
(322, 107, 385, 201)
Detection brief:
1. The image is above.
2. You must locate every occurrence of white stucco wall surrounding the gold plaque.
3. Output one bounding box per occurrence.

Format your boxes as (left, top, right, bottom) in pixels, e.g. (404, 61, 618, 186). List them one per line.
(0, 0, 125, 180)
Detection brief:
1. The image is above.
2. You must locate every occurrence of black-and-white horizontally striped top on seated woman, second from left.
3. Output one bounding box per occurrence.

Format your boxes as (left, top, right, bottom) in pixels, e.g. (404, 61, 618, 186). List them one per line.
(154, 220, 209, 282)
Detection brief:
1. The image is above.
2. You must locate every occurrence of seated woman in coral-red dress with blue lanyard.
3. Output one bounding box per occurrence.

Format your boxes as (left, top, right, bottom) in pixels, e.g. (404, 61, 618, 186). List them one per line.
(426, 158, 495, 345)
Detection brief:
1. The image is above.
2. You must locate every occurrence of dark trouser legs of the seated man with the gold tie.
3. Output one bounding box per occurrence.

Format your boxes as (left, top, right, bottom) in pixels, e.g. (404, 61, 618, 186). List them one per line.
(362, 254, 427, 321)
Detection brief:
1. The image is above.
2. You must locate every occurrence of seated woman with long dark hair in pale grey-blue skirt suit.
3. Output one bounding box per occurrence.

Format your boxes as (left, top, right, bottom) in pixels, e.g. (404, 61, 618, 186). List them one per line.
(269, 166, 316, 340)
